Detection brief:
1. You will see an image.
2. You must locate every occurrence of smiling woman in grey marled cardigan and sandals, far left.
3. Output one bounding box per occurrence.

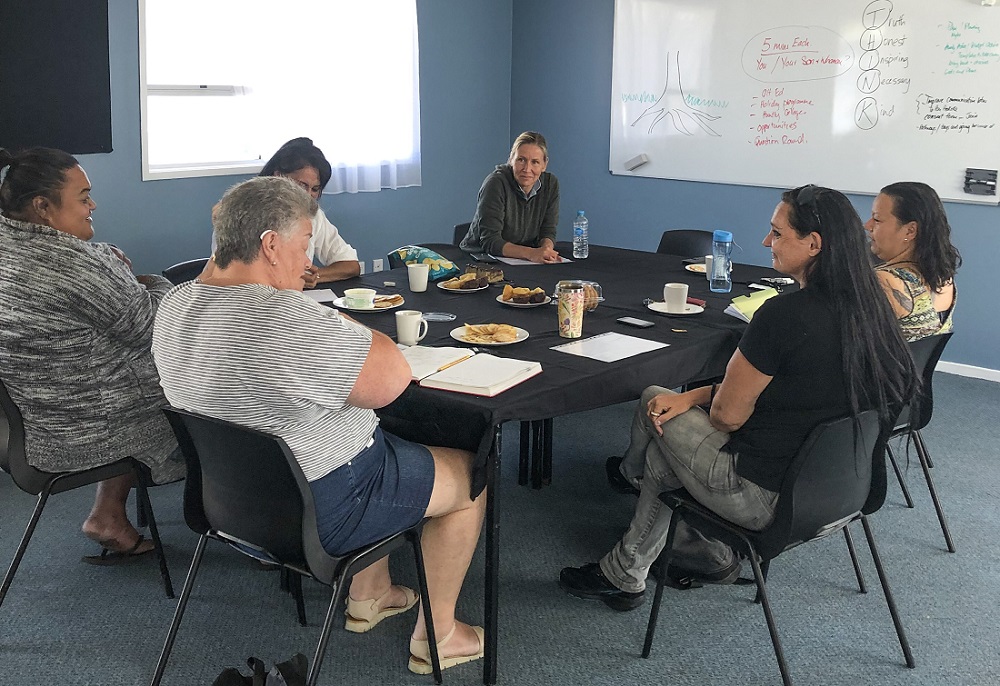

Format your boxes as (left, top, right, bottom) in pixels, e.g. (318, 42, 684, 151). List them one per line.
(0, 148, 184, 564)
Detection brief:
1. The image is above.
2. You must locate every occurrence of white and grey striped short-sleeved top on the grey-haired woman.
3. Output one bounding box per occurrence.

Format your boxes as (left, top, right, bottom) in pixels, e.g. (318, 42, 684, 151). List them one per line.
(153, 281, 378, 481)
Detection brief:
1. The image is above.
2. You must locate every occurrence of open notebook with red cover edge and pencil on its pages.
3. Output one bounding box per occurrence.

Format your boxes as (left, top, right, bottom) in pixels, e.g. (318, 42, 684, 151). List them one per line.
(403, 345, 542, 397)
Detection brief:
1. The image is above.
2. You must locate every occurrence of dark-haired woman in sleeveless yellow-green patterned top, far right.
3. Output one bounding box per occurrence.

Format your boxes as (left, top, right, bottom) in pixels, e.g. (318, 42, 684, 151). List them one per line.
(865, 181, 962, 341)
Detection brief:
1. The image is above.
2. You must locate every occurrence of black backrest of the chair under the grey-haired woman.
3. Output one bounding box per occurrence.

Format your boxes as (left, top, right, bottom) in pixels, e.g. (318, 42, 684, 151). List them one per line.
(164, 408, 336, 579)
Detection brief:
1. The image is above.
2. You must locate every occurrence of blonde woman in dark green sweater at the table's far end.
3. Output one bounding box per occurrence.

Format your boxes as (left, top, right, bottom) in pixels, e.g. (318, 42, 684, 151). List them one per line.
(461, 131, 560, 263)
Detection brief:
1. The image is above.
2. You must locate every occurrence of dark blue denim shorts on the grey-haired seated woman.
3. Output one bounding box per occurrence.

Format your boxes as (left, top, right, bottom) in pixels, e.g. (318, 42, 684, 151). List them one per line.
(309, 427, 434, 555)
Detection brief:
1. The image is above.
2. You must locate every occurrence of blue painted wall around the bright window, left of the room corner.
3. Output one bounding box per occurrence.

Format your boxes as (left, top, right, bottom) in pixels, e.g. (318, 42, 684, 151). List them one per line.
(71, 0, 512, 280)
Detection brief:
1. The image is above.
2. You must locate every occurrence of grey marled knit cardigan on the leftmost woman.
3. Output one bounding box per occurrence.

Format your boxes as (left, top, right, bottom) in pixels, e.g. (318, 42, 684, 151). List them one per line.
(0, 216, 184, 483)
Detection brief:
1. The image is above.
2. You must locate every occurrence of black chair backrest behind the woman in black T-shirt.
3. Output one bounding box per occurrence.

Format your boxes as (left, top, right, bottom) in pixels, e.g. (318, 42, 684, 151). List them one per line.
(758, 410, 885, 559)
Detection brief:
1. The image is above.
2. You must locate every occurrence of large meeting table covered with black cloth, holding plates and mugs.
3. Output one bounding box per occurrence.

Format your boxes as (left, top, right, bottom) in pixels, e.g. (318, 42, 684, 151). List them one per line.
(323, 244, 776, 684)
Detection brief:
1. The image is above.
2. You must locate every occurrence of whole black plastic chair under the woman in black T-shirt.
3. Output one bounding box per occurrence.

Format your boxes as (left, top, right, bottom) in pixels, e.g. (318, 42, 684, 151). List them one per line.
(642, 410, 915, 686)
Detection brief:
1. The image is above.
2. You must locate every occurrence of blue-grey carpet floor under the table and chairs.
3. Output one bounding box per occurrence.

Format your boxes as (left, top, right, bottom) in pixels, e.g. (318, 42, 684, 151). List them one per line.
(0, 374, 1000, 686)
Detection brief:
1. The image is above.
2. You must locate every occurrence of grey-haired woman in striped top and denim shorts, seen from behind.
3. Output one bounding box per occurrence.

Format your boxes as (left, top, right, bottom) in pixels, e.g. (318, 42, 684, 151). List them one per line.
(153, 177, 486, 674)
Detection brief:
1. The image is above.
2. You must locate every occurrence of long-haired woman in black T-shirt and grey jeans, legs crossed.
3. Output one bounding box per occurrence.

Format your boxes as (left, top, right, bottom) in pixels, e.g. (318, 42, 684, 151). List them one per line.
(559, 185, 917, 610)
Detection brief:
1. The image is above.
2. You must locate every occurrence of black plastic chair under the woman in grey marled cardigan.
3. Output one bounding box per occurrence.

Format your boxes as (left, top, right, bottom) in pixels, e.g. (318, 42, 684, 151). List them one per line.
(0, 381, 174, 605)
